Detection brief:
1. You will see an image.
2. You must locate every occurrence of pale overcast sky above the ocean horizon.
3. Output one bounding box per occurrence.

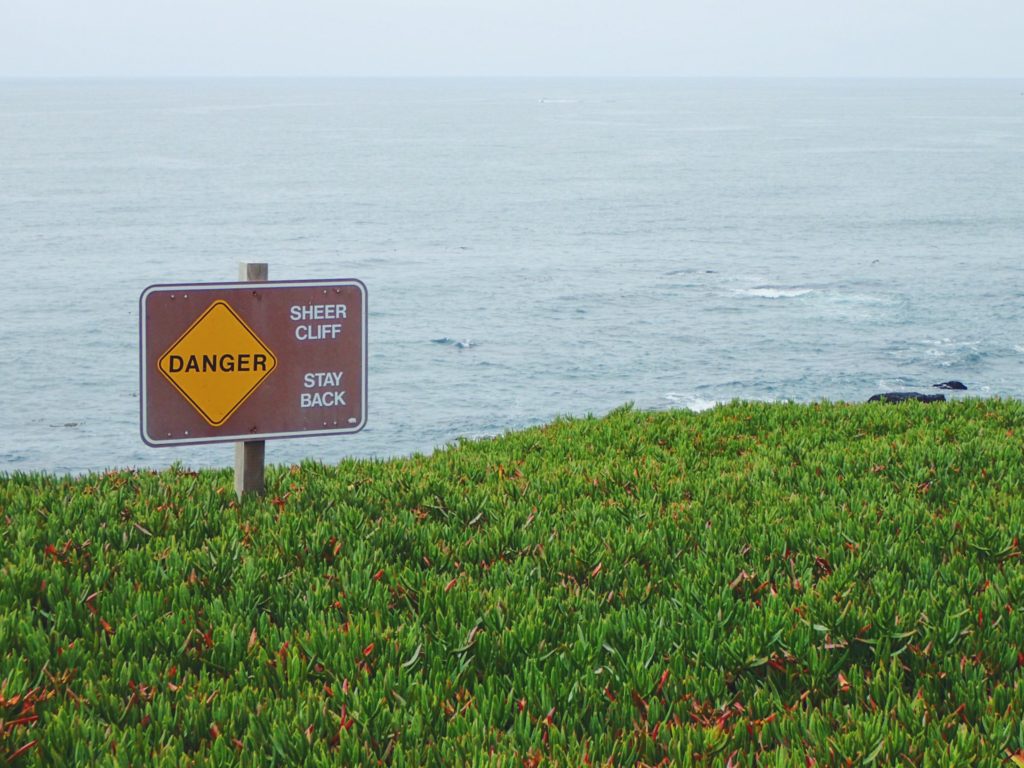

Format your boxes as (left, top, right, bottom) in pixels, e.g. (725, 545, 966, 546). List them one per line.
(0, 0, 1024, 77)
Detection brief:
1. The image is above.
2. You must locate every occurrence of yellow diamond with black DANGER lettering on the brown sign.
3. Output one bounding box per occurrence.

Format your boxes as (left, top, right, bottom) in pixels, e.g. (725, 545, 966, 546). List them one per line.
(157, 301, 278, 427)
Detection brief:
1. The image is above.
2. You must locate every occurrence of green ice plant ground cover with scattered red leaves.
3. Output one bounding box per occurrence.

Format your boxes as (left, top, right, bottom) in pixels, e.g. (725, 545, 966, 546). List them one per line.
(0, 400, 1024, 767)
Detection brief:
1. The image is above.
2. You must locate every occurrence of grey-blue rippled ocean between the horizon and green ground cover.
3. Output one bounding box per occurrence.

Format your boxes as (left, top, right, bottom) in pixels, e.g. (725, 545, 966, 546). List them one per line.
(0, 79, 1024, 473)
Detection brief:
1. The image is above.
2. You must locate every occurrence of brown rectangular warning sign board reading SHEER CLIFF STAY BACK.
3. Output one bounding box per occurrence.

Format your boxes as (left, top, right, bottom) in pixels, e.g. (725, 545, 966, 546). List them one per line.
(139, 280, 367, 445)
